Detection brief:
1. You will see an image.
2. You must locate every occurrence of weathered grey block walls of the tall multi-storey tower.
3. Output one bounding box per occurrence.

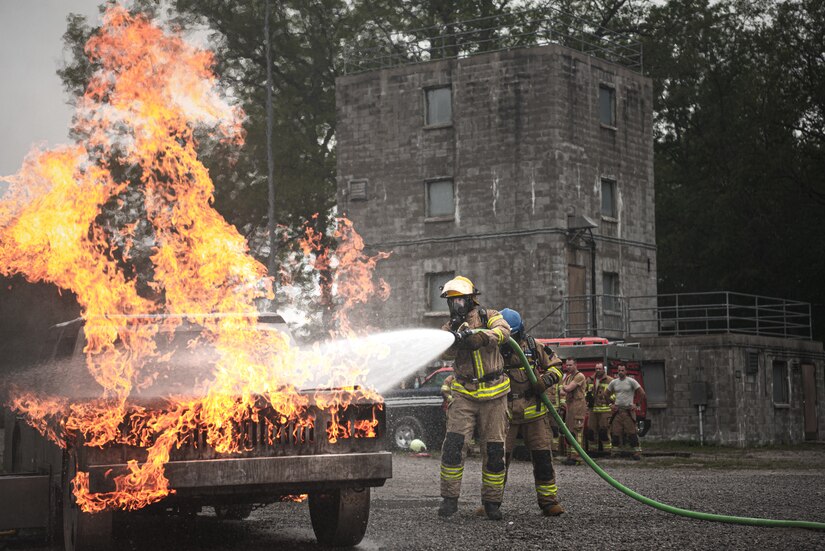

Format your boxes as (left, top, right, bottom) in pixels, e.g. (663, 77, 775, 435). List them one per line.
(336, 45, 656, 336)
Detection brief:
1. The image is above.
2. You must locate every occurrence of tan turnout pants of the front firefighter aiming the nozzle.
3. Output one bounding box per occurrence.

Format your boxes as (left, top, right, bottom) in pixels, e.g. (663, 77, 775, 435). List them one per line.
(441, 394, 507, 503)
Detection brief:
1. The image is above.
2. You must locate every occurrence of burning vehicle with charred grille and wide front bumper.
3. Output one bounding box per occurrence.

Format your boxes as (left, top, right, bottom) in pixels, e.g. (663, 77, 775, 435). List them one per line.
(0, 315, 392, 550)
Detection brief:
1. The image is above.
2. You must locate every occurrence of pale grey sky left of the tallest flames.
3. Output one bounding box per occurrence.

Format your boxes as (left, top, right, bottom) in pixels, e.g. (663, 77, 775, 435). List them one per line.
(0, 0, 101, 181)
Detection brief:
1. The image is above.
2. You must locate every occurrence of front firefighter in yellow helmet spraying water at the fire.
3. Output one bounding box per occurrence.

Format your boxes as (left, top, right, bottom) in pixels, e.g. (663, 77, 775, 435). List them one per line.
(438, 276, 510, 520)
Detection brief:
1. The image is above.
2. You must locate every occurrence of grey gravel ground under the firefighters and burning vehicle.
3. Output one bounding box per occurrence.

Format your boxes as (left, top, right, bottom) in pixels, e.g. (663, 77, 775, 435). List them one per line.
(0, 447, 825, 551)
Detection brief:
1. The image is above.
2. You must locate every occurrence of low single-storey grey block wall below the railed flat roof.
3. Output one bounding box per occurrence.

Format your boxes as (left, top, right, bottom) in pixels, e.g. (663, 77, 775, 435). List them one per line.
(637, 335, 825, 446)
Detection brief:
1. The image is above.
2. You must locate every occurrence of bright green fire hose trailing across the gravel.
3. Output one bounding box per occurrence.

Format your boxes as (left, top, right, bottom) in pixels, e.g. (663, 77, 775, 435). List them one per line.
(502, 338, 825, 530)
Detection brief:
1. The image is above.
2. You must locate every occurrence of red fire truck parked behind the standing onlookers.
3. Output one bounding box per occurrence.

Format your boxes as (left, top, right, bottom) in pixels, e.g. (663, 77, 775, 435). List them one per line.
(536, 337, 651, 444)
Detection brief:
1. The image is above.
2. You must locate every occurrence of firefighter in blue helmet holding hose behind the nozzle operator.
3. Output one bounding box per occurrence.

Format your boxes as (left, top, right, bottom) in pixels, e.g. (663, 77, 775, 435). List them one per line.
(501, 308, 564, 517)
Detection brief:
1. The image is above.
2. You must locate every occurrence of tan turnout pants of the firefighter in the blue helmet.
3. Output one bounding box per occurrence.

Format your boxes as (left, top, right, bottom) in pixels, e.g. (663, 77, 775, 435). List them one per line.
(505, 414, 558, 507)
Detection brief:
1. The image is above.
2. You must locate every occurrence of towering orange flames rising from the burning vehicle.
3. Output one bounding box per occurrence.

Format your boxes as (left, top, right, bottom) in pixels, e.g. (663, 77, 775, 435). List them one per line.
(0, 6, 388, 511)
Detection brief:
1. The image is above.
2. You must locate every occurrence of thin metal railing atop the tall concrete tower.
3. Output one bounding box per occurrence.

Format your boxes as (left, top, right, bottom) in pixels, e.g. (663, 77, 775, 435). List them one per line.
(343, 7, 643, 74)
